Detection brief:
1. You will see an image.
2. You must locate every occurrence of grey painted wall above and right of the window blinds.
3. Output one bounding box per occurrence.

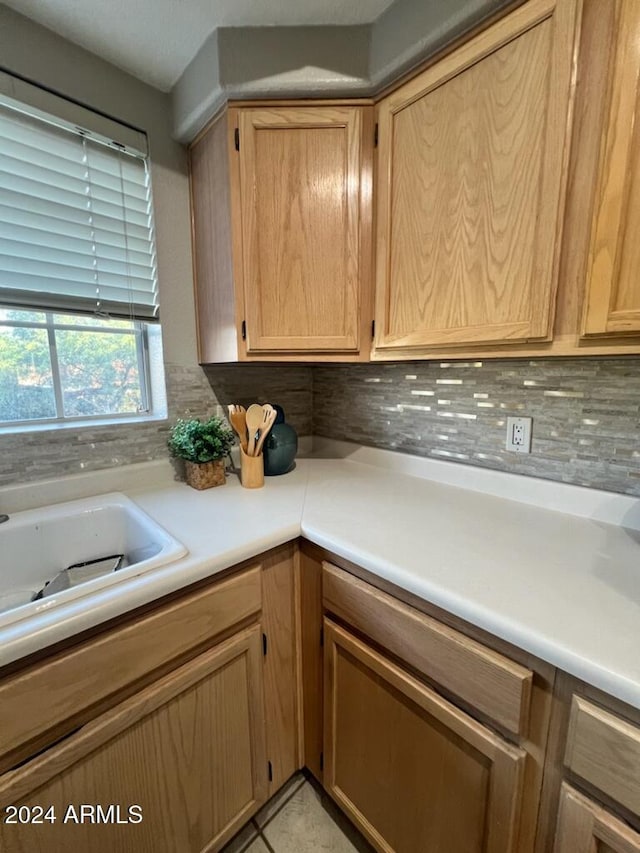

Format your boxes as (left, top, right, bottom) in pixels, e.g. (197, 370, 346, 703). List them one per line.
(0, 4, 197, 365)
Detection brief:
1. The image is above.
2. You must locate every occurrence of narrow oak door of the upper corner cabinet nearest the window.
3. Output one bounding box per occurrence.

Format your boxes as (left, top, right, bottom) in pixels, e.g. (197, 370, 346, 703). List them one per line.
(237, 106, 373, 355)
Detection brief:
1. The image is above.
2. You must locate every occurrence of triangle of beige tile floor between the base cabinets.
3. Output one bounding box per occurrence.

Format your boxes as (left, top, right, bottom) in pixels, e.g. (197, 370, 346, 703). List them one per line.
(222, 773, 372, 853)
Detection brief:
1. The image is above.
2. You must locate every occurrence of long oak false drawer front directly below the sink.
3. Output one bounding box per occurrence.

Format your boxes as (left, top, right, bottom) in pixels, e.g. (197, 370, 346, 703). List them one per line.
(0, 566, 261, 772)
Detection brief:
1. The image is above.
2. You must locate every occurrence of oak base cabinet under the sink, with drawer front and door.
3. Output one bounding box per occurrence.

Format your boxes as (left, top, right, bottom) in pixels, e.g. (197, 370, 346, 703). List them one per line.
(0, 543, 302, 853)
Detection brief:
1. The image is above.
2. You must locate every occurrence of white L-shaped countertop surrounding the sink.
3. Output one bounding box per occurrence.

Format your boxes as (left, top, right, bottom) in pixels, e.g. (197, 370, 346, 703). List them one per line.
(0, 443, 640, 708)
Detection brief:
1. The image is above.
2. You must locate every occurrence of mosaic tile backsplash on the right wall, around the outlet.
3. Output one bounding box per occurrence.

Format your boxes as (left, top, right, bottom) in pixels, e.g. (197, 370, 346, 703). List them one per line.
(313, 357, 640, 496)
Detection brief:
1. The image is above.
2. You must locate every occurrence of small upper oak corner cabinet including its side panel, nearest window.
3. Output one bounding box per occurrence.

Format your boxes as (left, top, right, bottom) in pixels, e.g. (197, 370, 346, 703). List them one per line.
(191, 104, 373, 362)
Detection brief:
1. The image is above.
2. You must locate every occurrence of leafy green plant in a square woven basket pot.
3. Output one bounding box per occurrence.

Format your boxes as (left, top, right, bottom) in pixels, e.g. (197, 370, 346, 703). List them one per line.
(168, 418, 234, 489)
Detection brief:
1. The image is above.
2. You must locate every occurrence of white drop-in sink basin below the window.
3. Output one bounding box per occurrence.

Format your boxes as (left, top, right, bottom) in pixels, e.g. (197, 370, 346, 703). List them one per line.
(0, 493, 187, 626)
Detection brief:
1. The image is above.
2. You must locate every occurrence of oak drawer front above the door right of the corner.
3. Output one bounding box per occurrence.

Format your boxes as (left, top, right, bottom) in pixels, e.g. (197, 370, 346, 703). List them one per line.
(322, 563, 533, 735)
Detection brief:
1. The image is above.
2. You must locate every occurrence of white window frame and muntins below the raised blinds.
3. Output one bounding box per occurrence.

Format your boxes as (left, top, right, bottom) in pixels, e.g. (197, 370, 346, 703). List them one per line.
(0, 305, 154, 434)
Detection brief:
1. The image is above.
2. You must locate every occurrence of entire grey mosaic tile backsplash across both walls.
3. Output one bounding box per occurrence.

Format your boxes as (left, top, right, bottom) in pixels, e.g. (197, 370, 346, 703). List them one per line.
(0, 357, 640, 496)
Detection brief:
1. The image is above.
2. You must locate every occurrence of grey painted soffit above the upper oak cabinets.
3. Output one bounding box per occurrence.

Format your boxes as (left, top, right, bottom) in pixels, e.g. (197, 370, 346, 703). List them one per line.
(172, 0, 523, 142)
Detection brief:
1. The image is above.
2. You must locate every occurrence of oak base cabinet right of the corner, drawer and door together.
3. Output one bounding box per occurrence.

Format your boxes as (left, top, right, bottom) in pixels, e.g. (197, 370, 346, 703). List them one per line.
(322, 562, 553, 853)
